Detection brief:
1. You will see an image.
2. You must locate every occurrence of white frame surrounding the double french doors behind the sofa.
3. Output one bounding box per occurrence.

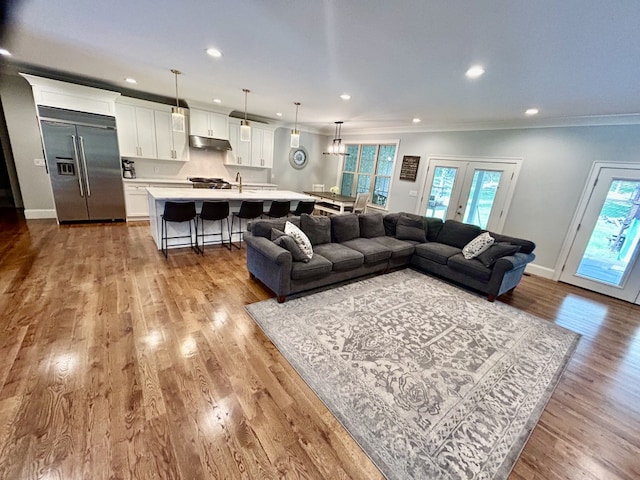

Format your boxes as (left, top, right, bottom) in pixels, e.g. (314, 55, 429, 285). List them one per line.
(414, 155, 523, 233)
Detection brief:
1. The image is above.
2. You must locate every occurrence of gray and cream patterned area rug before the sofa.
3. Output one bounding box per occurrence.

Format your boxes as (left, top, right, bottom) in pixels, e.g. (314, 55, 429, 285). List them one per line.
(246, 269, 579, 480)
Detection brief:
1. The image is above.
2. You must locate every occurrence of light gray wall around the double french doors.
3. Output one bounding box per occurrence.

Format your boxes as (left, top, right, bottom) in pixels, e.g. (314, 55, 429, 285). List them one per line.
(343, 125, 640, 276)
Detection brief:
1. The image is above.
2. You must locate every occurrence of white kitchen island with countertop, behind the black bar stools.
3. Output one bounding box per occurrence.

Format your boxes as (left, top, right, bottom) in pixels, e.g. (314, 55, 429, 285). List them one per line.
(147, 188, 315, 250)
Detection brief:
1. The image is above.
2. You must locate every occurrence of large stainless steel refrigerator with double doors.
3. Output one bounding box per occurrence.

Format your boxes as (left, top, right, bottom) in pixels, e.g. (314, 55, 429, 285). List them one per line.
(38, 106, 126, 223)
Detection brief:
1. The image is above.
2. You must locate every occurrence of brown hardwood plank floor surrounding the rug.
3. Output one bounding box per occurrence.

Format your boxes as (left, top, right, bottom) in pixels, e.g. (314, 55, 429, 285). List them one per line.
(0, 215, 640, 480)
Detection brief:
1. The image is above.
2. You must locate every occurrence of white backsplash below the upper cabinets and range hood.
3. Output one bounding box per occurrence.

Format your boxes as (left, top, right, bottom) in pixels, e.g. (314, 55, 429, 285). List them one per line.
(134, 148, 269, 182)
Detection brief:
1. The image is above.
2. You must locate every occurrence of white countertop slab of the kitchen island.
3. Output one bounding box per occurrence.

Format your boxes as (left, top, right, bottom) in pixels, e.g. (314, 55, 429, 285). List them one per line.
(147, 187, 315, 201)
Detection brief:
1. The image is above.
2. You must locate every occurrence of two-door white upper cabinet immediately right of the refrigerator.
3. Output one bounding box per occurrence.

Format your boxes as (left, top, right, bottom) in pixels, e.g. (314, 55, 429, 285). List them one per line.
(116, 103, 157, 158)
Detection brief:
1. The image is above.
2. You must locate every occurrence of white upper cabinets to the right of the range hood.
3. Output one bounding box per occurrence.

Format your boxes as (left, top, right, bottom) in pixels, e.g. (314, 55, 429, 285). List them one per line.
(225, 119, 273, 168)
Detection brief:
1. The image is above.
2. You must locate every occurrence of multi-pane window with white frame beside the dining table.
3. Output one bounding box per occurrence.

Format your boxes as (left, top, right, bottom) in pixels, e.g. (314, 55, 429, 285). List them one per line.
(340, 145, 396, 207)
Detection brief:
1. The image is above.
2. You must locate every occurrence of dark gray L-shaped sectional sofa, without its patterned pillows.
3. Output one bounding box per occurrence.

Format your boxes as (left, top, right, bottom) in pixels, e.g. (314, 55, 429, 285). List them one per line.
(244, 213, 535, 302)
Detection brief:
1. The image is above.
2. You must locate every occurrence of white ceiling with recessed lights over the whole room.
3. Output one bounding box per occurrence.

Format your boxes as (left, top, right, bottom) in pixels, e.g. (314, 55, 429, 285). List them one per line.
(3, 0, 640, 134)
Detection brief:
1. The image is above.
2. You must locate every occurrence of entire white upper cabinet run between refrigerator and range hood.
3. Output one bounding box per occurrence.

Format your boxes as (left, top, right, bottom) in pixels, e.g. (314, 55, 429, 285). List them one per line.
(116, 98, 189, 162)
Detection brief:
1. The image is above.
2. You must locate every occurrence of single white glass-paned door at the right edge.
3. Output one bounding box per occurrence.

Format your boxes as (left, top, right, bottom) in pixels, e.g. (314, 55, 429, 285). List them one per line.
(560, 166, 640, 304)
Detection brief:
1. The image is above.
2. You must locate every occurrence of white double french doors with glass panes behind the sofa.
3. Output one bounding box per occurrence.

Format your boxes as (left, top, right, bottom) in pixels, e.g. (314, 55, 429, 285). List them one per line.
(421, 158, 518, 231)
